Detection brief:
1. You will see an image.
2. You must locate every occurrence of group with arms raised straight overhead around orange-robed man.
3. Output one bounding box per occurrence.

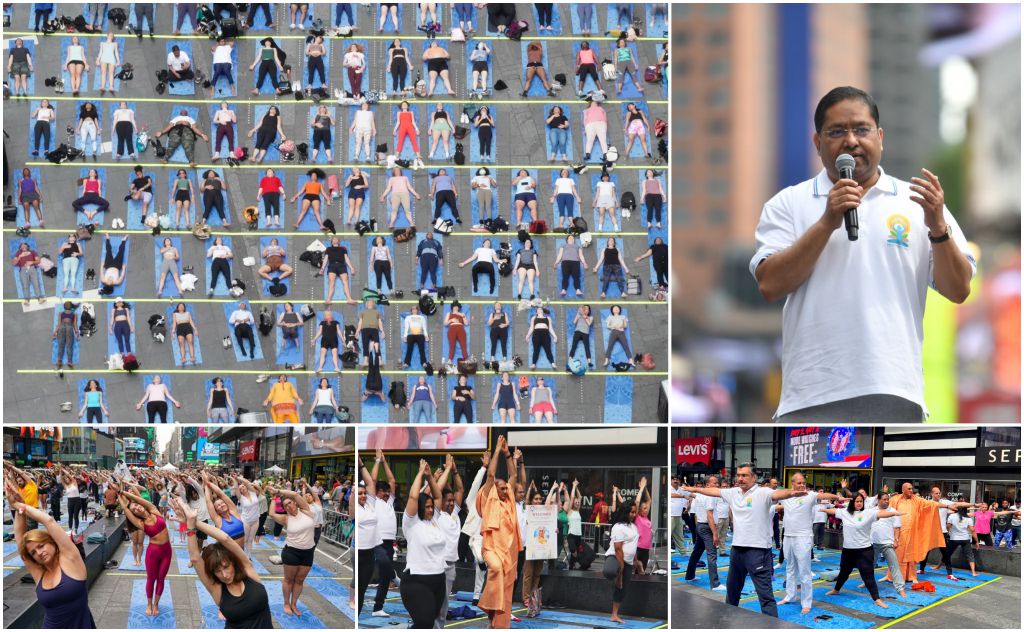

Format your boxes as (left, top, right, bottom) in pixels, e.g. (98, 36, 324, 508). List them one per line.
(353, 436, 653, 628)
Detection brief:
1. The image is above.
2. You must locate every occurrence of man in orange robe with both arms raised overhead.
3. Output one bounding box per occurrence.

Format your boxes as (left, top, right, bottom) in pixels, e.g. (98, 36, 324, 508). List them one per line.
(476, 436, 522, 629)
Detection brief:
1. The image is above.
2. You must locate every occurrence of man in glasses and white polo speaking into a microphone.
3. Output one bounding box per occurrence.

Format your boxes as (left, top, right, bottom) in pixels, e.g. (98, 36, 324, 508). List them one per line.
(750, 87, 977, 423)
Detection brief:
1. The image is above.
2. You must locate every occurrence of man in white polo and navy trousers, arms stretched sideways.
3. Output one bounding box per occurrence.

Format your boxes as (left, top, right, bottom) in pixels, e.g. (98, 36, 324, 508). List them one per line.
(683, 463, 807, 617)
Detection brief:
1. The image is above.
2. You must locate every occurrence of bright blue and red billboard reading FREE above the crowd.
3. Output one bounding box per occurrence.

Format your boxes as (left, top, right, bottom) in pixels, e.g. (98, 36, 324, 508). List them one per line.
(785, 426, 871, 468)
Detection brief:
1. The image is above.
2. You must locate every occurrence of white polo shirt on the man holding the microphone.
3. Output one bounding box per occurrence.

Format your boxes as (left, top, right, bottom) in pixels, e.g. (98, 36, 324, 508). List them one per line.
(750, 167, 977, 416)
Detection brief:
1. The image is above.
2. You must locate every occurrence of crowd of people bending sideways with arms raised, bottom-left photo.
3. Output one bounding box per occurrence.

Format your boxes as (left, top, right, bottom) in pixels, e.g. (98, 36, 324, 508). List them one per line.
(4, 461, 351, 629)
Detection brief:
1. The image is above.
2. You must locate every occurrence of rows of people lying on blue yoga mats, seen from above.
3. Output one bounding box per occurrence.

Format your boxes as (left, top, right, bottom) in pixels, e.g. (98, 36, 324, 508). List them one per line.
(7, 3, 669, 422)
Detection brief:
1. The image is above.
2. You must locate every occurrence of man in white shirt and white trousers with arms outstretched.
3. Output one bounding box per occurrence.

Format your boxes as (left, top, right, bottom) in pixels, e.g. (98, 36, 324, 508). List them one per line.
(775, 472, 846, 615)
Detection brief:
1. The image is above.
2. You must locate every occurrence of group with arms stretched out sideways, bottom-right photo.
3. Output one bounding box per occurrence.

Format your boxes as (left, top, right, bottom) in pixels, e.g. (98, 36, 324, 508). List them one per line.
(669, 463, 1020, 617)
